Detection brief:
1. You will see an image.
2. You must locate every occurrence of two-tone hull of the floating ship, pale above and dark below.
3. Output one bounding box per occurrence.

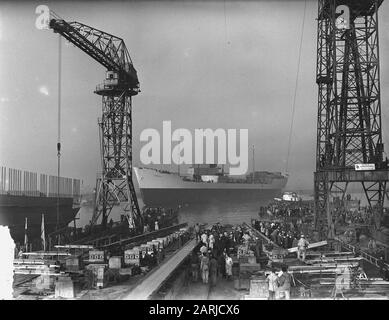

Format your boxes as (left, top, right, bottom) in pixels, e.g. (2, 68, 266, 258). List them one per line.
(134, 168, 286, 207)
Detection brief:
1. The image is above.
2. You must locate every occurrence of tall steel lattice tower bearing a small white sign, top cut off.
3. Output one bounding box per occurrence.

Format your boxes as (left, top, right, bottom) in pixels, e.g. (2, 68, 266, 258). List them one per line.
(314, 0, 389, 238)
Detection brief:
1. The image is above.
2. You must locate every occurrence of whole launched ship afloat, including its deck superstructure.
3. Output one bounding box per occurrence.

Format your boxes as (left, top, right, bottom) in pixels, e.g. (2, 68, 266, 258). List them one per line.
(134, 164, 288, 206)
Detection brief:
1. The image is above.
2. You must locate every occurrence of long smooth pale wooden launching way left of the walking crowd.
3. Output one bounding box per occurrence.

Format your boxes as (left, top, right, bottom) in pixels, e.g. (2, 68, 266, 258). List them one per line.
(124, 239, 198, 300)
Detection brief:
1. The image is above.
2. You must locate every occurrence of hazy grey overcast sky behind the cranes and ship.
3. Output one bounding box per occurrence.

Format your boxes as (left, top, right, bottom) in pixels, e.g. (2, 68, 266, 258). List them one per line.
(0, 0, 389, 189)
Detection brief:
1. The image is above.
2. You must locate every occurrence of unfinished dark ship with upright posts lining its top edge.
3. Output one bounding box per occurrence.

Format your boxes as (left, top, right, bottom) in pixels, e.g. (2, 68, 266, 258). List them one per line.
(0, 167, 81, 243)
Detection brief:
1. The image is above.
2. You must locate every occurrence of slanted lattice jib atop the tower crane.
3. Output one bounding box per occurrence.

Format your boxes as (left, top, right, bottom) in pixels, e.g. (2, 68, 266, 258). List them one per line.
(49, 19, 139, 89)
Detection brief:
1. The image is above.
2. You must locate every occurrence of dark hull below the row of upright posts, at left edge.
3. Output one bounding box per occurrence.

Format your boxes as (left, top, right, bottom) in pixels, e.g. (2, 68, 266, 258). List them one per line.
(0, 195, 80, 243)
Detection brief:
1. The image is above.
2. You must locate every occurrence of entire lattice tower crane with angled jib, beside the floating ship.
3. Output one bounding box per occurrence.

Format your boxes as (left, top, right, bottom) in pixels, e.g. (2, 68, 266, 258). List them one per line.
(49, 13, 141, 227)
